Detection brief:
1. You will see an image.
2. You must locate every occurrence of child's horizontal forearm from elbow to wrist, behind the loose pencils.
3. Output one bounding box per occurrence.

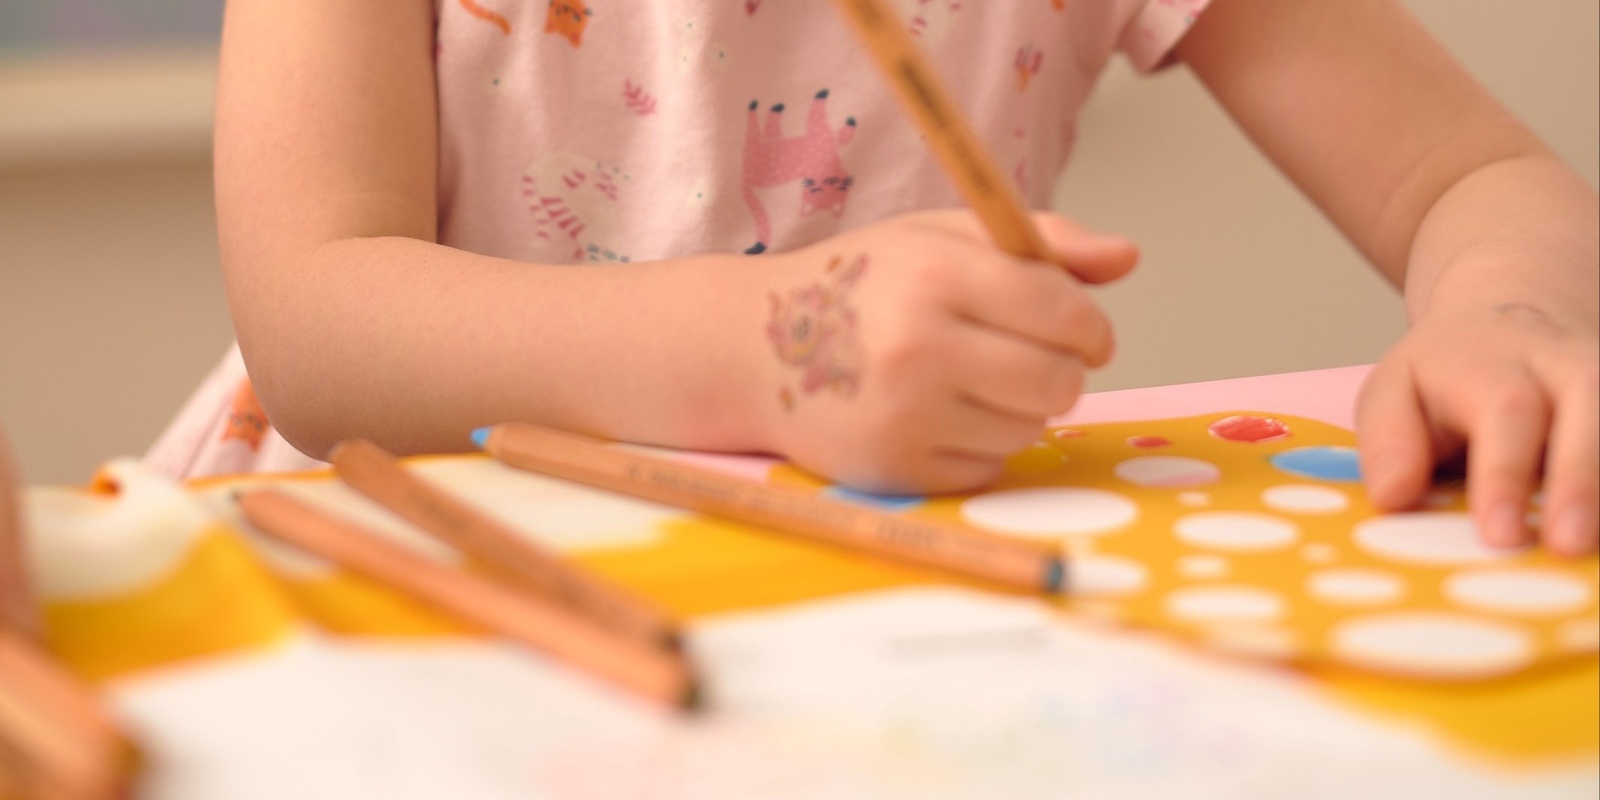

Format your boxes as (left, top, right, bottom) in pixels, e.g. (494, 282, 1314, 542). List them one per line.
(229, 237, 778, 456)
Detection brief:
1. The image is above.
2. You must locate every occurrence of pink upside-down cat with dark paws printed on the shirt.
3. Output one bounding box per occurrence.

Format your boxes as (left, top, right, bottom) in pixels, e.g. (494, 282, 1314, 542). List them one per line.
(742, 90, 856, 256)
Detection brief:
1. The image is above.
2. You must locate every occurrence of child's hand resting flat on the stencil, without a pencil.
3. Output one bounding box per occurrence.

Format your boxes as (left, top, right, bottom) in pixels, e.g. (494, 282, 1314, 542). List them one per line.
(1357, 304, 1600, 555)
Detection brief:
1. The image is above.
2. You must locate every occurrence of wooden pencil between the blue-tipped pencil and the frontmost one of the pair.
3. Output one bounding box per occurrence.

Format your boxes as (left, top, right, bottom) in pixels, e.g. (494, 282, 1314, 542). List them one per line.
(330, 440, 678, 650)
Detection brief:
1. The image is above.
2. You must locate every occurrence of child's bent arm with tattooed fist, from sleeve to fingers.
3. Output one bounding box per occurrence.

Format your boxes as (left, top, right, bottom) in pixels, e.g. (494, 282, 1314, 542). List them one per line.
(216, 0, 1134, 490)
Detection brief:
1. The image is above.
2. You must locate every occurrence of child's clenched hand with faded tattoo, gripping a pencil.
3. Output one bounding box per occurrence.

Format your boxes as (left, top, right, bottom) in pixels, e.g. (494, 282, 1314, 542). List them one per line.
(766, 211, 1138, 491)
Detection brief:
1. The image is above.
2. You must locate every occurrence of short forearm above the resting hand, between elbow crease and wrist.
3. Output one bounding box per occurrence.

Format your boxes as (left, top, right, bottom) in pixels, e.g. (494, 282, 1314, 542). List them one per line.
(1405, 154, 1600, 328)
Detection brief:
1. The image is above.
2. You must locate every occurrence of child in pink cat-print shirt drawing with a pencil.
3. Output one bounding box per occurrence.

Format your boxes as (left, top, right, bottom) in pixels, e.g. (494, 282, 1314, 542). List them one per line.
(152, 0, 1600, 554)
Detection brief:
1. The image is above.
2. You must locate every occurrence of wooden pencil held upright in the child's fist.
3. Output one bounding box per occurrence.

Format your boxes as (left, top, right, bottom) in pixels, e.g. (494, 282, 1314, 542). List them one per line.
(838, 0, 1050, 261)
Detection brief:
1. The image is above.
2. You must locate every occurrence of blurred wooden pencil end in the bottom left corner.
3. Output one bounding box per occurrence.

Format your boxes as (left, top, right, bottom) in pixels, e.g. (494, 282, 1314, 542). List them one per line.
(0, 630, 138, 800)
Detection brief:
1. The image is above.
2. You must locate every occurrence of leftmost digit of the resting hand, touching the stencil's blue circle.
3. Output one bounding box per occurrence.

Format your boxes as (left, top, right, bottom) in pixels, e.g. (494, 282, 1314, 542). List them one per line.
(1355, 363, 1437, 510)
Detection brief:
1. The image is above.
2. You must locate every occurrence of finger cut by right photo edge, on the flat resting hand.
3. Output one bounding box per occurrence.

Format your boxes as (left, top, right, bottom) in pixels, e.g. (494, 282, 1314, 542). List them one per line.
(1542, 369, 1600, 555)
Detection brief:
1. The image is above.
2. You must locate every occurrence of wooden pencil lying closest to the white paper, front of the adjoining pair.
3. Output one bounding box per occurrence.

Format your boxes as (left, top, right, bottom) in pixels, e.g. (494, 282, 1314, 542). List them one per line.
(238, 488, 696, 706)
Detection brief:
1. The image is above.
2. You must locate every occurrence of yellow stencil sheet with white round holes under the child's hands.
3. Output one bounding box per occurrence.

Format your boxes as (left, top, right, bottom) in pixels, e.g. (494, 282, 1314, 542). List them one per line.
(773, 413, 1600, 680)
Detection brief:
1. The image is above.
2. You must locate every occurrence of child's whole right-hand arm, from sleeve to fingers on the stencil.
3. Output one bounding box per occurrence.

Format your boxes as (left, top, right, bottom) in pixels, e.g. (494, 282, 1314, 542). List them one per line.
(1178, 0, 1600, 554)
